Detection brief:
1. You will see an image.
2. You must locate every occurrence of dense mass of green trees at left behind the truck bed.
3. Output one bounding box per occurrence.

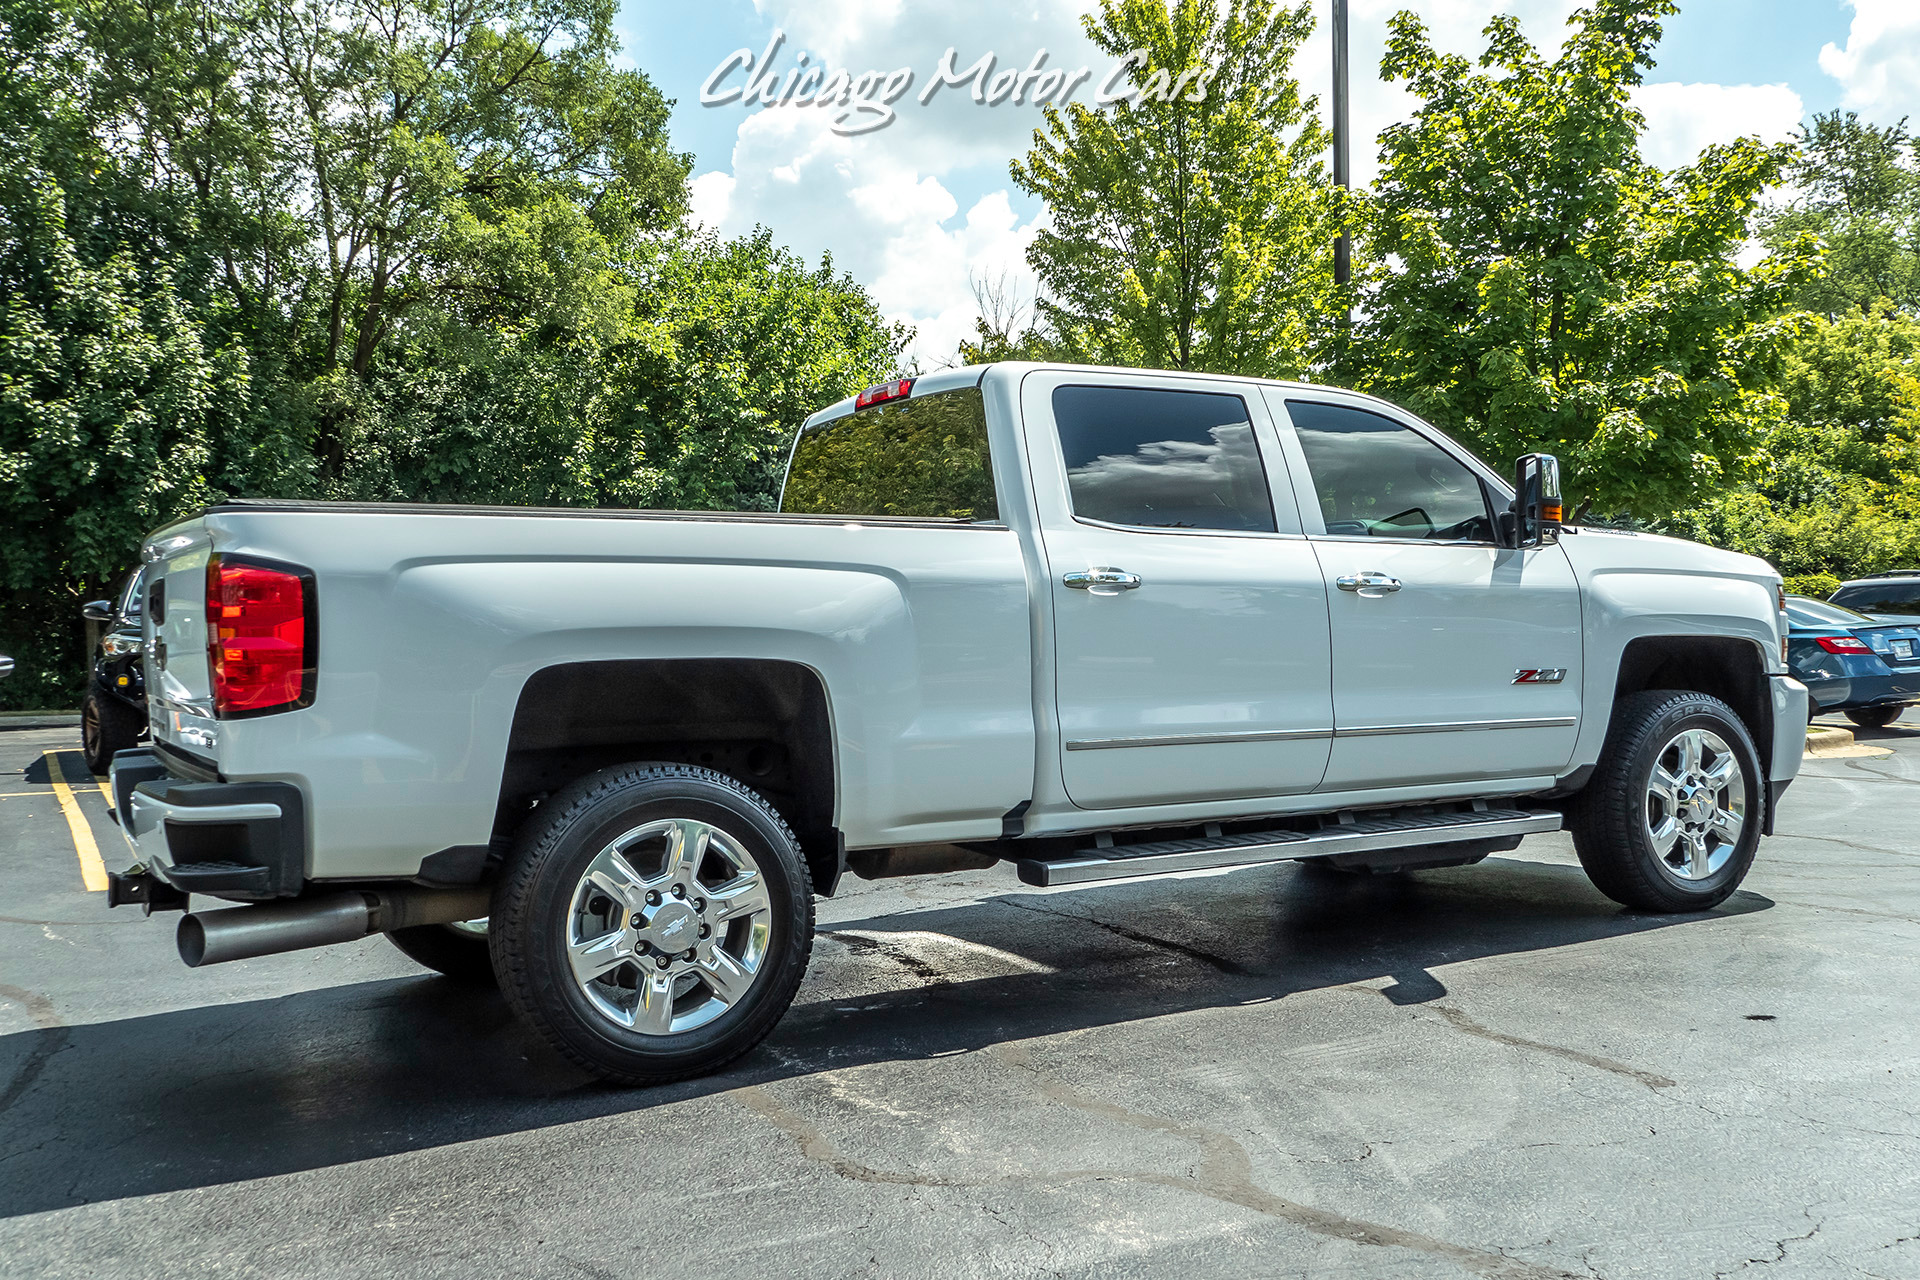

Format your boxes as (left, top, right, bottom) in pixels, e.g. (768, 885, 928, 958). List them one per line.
(0, 0, 904, 706)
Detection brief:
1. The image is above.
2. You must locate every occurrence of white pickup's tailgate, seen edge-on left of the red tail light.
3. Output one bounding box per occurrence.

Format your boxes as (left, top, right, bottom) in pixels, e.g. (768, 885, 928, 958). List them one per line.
(142, 520, 219, 756)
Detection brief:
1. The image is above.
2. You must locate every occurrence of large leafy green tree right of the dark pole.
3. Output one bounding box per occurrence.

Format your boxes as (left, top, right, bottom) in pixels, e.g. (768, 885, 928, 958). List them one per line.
(1348, 0, 1814, 516)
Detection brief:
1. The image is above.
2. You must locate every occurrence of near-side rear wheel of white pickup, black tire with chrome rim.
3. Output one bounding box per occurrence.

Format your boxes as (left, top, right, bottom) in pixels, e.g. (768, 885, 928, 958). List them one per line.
(488, 764, 814, 1084)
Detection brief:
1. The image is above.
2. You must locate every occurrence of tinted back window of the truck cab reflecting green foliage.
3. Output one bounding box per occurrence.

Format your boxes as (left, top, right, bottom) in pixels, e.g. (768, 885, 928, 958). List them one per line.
(780, 388, 1000, 522)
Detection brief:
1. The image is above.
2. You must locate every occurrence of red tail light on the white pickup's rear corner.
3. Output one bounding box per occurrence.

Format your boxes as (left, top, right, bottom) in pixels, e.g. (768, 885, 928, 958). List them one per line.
(207, 555, 319, 720)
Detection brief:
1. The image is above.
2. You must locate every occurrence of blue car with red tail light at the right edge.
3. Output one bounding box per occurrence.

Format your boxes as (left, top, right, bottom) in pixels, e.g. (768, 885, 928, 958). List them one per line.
(1788, 595, 1920, 729)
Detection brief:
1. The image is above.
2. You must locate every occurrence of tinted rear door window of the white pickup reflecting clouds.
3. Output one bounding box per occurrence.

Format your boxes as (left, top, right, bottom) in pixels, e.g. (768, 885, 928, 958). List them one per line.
(1052, 386, 1279, 533)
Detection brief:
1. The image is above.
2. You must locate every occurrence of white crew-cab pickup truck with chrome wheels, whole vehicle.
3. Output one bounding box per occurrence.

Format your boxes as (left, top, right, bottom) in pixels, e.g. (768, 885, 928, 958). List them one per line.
(111, 365, 1807, 1082)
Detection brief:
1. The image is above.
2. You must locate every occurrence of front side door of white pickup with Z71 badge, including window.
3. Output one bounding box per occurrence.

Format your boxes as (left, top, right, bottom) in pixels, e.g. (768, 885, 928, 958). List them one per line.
(1267, 390, 1582, 791)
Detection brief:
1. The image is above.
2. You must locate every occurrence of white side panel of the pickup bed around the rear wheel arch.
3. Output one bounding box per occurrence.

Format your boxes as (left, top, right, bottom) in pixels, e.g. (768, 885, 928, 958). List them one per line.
(183, 510, 1033, 877)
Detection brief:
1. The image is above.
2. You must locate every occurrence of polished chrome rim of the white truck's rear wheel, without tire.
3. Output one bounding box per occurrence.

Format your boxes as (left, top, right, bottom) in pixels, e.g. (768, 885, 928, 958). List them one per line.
(566, 818, 774, 1036)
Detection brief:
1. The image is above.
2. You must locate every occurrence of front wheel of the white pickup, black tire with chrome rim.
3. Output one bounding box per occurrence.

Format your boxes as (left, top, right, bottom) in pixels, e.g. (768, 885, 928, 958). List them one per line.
(1569, 689, 1766, 913)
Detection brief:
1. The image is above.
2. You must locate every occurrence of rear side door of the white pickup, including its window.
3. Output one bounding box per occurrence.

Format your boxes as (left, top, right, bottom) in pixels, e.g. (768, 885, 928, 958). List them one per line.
(1021, 372, 1332, 808)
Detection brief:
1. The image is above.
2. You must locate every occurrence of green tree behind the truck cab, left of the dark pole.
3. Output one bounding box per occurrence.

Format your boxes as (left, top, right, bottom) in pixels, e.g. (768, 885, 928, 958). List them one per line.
(1012, 0, 1340, 376)
